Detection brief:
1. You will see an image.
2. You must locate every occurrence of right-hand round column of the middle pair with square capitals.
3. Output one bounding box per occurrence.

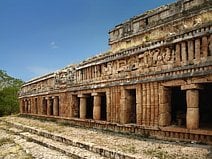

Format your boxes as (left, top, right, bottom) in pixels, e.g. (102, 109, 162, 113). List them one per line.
(92, 93, 101, 120)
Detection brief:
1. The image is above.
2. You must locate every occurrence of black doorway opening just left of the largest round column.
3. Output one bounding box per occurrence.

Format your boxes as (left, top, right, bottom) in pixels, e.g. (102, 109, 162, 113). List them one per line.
(171, 87, 187, 127)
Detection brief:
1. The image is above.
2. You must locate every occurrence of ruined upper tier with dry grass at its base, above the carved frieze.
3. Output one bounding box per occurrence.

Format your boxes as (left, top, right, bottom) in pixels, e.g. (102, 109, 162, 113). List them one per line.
(109, 0, 212, 52)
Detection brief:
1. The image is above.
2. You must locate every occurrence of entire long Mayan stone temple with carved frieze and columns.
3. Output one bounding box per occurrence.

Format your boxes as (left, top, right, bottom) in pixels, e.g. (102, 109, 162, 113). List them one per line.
(19, 0, 212, 143)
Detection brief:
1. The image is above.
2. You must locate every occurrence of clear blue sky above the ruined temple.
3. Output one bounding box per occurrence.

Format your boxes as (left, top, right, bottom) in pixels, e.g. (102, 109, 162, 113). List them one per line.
(0, 0, 174, 81)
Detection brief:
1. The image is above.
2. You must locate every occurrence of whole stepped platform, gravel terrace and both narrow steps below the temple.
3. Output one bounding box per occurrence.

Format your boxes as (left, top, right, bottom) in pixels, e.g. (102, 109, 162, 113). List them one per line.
(0, 117, 211, 159)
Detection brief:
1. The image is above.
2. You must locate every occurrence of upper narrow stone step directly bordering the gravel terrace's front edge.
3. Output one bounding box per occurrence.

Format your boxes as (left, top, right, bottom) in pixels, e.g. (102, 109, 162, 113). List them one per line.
(3, 120, 136, 159)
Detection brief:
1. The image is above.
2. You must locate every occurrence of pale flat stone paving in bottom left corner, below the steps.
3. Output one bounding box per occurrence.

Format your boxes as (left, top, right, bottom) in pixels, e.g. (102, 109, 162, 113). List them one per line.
(0, 122, 73, 159)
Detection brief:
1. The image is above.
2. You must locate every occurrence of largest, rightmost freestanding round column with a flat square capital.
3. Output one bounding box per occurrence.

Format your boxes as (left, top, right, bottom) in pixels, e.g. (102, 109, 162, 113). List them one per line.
(181, 84, 201, 129)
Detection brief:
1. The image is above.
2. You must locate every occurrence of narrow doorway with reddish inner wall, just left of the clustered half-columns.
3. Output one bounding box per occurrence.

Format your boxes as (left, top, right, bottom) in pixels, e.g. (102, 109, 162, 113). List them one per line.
(126, 89, 136, 123)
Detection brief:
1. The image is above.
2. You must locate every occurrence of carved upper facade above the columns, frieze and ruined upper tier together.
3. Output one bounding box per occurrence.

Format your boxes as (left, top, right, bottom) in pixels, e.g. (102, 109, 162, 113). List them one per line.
(19, 0, 212, 97)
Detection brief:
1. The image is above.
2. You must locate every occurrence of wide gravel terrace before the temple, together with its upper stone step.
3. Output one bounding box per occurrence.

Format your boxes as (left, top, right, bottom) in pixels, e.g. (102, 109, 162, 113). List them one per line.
(0, 117, 210, 159)
